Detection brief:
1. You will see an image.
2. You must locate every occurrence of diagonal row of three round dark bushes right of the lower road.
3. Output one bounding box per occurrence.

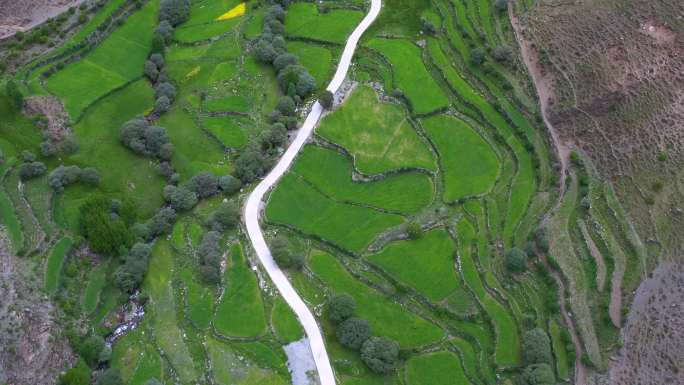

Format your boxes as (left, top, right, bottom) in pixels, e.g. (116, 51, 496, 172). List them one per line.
(328, 294, 399, 374)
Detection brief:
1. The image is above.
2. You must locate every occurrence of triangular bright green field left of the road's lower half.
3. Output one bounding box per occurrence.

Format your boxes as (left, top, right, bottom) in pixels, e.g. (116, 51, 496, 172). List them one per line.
(213, 245, 266, 337)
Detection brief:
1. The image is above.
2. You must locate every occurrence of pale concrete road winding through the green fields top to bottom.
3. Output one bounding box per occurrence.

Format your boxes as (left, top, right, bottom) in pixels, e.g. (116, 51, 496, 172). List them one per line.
(244, 0, 382, 385)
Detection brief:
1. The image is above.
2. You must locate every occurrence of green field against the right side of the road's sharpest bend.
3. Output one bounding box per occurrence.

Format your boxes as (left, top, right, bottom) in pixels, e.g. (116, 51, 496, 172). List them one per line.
(266, 175, 403, 251)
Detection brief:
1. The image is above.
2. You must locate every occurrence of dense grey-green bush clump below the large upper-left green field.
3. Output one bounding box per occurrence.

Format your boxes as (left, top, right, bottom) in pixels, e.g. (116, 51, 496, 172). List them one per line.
(120, 118, 173, 161)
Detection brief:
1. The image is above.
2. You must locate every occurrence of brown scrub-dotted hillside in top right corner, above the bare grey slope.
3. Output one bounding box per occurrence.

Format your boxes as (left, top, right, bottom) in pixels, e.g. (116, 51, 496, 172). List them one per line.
(520, 0, 684, 253)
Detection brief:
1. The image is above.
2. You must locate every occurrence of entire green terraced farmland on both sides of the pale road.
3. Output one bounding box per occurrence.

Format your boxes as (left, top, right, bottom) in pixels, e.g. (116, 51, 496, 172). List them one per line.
(0, 0, 652, 385)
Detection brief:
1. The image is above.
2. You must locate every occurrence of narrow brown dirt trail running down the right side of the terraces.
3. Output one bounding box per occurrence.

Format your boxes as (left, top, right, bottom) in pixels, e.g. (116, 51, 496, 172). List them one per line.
(508, 4, 587, 385)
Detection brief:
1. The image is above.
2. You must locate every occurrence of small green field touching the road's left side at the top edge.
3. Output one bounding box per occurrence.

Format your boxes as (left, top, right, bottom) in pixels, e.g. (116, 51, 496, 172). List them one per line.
(285, 2, 363, 43)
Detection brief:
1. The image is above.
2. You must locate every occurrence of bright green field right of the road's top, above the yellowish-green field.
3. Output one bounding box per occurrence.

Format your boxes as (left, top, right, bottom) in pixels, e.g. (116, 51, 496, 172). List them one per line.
(368, 39, 449, 114)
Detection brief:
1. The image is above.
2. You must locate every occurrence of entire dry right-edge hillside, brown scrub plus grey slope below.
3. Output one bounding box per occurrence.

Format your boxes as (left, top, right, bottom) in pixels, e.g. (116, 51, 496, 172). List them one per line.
(515, 0, 684, 384)
